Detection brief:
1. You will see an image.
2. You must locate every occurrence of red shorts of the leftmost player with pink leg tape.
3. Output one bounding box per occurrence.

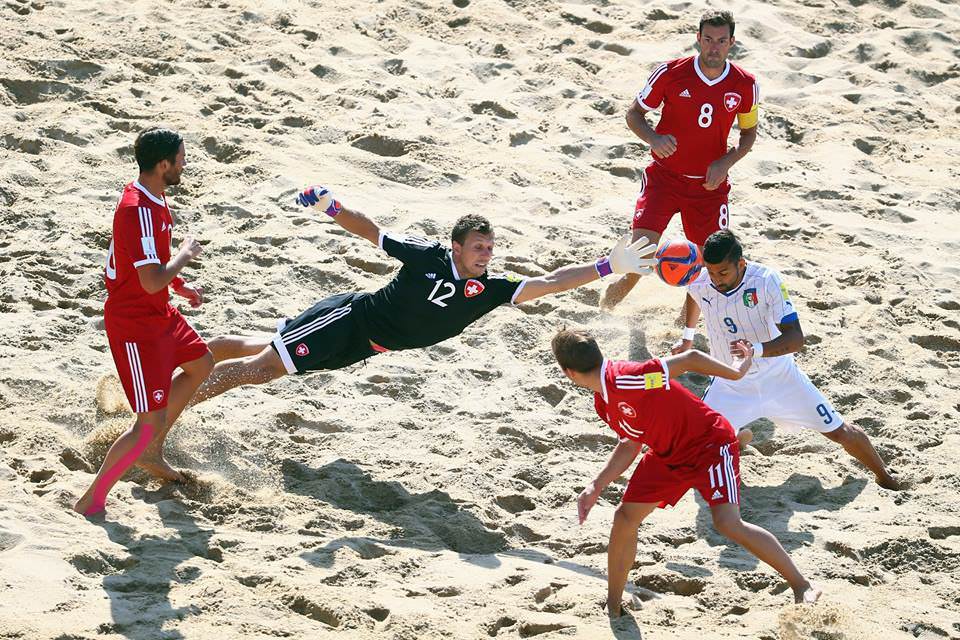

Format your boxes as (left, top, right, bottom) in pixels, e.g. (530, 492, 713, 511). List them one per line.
(107, 311, 207, 413)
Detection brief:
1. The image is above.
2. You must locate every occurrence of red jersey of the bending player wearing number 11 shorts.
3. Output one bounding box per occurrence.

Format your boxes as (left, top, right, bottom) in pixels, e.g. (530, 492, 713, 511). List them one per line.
(594, 358, 737, 467)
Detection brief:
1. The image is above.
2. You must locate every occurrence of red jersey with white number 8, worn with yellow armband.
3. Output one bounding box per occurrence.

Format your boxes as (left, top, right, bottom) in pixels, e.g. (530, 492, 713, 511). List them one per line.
(637, 56, 760, 178)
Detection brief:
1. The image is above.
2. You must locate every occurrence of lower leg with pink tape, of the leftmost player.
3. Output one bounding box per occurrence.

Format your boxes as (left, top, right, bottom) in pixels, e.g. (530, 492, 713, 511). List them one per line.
(73, 409, 166, 516)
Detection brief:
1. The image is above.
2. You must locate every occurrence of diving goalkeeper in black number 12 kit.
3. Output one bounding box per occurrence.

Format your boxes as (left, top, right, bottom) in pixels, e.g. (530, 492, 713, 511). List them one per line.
(163, 187, 656, 416)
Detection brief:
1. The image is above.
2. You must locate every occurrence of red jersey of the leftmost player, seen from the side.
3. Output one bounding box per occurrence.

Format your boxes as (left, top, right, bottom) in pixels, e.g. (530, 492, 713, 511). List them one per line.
(104, 181, 175, 337)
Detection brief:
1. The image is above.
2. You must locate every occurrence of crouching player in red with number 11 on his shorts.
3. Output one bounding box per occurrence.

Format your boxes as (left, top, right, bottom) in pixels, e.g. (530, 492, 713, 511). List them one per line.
(552, 330, 820, 617)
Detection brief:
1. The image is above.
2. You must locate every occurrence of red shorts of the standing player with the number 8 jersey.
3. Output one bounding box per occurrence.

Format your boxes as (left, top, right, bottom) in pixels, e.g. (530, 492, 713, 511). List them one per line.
(631, 162, 730, 247)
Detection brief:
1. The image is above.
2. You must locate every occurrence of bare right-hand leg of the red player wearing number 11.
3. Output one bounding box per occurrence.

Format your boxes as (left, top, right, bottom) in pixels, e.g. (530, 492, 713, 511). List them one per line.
(710, 502, 820, 603)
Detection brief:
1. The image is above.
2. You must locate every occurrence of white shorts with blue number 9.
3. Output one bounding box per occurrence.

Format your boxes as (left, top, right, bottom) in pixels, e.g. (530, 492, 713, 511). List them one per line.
(703, 360, 843, 433)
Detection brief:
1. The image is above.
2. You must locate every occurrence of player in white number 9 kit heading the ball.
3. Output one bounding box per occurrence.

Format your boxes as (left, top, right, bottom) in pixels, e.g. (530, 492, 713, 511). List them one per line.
(673, 229, 900, 490)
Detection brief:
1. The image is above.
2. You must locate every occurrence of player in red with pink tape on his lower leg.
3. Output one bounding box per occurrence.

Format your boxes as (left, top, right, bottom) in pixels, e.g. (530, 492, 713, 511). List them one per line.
(73, 128, 213, 515)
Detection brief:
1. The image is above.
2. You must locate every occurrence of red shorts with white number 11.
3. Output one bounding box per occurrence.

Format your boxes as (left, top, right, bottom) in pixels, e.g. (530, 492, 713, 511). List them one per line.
(623, 440, 740, 509)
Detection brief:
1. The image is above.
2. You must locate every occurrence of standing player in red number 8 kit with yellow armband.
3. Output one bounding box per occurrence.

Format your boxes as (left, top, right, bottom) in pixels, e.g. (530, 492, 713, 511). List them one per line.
(600, 11, 760, 309)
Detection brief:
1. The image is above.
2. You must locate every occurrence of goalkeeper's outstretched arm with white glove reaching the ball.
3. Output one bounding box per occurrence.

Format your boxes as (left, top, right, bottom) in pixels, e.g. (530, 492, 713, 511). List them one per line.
(514, 233, 657, 304)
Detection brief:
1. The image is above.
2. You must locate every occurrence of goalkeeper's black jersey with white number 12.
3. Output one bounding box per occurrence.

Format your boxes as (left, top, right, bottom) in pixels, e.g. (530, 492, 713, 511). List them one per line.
(352, 233, 524, 351)
